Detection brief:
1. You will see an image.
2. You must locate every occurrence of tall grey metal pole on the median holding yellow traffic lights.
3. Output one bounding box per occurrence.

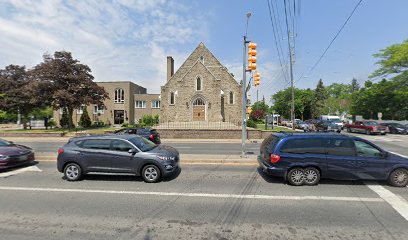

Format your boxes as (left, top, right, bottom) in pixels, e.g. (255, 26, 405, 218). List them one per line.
(241, 12, 252, 158)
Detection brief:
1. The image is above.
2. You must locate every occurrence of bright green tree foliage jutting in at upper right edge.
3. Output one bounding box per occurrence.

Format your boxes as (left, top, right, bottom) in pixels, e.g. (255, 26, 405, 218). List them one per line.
(370, 40, 408, 78)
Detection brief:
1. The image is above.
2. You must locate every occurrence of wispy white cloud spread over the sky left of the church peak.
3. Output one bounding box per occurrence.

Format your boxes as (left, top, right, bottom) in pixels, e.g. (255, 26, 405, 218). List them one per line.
(0, 0, 207, 93)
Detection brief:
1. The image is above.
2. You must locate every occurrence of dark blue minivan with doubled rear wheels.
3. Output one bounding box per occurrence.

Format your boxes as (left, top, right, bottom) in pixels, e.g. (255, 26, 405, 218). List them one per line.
(258, 133, 408, 187)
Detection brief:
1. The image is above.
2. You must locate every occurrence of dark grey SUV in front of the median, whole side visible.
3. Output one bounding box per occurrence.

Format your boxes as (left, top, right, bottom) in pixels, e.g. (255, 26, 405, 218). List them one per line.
(57, 135, 180, 183)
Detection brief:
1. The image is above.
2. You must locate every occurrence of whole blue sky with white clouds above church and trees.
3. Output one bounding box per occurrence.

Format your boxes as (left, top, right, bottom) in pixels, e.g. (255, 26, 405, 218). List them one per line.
(0, 0, 408, 104)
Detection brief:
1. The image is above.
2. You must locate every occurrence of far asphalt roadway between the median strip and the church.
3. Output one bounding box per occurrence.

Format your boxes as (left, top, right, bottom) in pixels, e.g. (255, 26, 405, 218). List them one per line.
(4, 131, 408, 155)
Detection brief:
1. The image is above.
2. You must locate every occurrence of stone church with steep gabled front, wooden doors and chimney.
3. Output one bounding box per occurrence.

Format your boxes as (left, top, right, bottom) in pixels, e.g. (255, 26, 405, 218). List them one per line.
(160, 43, 242, 125)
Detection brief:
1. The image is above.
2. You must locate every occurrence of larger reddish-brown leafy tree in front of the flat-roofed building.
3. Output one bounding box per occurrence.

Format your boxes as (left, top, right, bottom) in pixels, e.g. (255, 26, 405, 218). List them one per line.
(30, 51, 108, 127)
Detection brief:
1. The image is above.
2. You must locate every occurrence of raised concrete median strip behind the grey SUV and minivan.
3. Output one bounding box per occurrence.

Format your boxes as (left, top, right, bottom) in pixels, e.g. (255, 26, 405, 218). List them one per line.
(35, 152, 258, 165)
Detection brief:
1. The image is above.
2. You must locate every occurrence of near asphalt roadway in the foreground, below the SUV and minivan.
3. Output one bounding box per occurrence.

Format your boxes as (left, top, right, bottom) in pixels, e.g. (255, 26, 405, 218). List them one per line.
(0, 162, 408, 240)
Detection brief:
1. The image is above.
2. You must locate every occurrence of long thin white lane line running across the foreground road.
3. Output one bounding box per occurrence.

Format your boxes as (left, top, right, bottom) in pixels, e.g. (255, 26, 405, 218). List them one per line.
(0, 187, 384, 202)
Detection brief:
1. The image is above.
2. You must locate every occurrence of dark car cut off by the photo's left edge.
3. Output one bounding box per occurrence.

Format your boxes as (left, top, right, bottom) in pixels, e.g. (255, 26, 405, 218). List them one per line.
(0, 139, 34, 169)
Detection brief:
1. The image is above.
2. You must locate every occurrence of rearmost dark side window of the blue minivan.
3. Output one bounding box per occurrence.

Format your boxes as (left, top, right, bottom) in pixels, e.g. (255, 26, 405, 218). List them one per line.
(280, 138, 325, 154)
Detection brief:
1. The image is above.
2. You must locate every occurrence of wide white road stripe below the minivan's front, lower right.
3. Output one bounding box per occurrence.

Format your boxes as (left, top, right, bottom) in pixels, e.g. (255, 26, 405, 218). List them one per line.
(365, 183, 408, 221)
